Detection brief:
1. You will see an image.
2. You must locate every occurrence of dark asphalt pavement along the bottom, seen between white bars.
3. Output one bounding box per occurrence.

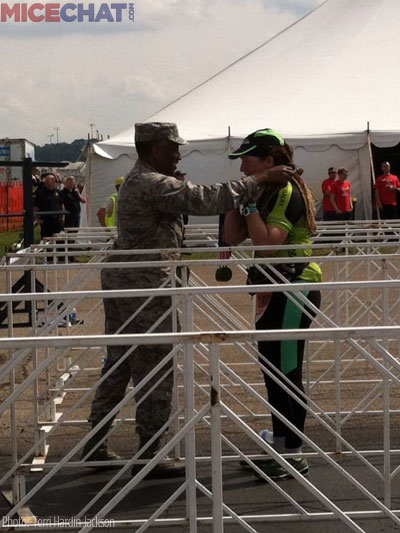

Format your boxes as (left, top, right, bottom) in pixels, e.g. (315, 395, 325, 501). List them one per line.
(0, 448, 400, 533)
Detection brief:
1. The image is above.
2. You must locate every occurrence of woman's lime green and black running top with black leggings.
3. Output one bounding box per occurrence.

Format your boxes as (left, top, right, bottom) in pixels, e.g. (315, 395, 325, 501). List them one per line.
(256, 182, 321, 450)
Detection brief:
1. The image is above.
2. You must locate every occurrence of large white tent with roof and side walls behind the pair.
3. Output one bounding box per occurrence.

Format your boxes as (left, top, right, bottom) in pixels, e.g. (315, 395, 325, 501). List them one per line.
(91, 0, 400, 222)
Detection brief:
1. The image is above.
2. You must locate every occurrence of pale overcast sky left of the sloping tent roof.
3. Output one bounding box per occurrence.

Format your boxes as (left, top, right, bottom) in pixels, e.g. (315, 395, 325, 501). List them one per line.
(0, 0, 329, 144)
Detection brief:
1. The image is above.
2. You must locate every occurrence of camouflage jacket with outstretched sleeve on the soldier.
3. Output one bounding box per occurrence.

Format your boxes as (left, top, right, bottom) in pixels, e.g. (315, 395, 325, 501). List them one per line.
(110, 160, 260, 261)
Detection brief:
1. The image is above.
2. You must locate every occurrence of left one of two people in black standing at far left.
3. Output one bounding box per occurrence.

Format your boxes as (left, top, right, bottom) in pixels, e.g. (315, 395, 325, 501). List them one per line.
(33, 172, 64, 239)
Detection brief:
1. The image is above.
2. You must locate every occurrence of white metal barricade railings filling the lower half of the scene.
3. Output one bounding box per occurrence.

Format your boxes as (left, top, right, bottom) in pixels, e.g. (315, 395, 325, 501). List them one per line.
(0, 221, 400, 533)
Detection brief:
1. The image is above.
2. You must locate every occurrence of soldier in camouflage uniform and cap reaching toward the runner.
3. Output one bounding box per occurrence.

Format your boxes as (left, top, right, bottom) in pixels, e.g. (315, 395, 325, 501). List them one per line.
(83, 123, 292, 472)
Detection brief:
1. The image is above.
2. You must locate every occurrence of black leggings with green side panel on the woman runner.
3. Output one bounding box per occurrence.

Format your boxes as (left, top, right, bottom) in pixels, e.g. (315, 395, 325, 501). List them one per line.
(256, 291, 321, 450)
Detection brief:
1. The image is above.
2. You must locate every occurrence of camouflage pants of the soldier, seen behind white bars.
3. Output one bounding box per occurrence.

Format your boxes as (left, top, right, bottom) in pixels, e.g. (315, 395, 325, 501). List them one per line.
(89, 271, 173, 441)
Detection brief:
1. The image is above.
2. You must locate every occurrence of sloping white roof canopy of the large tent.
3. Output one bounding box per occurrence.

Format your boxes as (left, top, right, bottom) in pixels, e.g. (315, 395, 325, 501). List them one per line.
(96, 0, 400, 144)
